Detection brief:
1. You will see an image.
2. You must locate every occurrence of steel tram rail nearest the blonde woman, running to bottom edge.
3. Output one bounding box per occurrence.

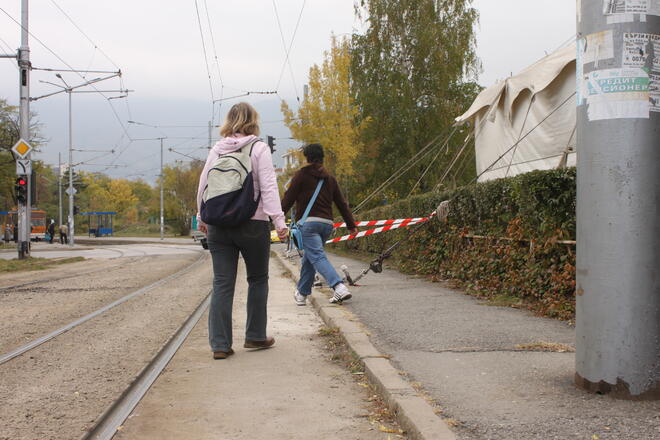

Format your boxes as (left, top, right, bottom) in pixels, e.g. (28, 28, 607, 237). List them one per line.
(82, 290, 212, 440)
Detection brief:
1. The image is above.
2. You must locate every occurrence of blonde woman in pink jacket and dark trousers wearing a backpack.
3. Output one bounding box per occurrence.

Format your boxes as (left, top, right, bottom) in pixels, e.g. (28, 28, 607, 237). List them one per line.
(197, 102, 288, 359)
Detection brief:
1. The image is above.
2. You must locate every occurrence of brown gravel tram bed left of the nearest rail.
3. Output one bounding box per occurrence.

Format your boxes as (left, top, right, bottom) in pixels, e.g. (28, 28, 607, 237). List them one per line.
(0, 251, 211, 440)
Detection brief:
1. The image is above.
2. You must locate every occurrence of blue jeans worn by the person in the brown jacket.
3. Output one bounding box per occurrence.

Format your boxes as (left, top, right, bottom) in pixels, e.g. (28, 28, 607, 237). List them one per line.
(298, 222, 342, 296)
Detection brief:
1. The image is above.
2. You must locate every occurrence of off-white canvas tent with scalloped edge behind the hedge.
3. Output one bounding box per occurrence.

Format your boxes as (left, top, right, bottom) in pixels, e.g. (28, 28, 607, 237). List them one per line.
(456, 45, 576, 182)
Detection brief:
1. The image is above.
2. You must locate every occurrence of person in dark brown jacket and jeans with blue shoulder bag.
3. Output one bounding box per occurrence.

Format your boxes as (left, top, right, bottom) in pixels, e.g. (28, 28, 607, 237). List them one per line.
(282, 144, 357, 306)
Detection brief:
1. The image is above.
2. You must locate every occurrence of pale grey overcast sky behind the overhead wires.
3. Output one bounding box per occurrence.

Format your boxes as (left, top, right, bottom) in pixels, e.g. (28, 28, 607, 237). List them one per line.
(0, 0, 575, 182)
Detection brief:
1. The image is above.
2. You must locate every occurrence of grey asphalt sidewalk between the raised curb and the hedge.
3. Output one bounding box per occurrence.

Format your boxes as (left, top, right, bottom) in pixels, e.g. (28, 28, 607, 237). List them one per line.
(318, 251, 660, 440)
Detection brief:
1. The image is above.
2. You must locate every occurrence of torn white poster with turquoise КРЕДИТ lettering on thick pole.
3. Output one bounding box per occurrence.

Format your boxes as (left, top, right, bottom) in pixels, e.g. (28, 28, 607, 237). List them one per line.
(583, 68, 651, 121)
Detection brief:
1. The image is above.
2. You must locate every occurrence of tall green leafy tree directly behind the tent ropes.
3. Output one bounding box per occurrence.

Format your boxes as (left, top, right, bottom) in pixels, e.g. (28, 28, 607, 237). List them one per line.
(351, 0, 478, 206)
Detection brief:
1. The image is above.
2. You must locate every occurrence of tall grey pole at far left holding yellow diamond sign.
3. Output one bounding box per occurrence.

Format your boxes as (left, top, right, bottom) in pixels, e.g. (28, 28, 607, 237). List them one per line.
(16, 0, 32, 259)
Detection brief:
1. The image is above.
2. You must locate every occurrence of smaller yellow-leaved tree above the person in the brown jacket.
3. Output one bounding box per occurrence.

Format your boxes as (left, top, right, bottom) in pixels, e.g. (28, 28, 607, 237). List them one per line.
(282, 37, 368, 182)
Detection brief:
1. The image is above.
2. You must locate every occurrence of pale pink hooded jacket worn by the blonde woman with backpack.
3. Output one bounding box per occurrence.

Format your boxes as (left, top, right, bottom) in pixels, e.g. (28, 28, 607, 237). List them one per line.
(197, 134, 286, 229)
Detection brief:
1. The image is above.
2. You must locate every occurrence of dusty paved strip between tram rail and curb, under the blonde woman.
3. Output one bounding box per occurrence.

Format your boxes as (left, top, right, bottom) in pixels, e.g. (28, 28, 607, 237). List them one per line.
(115, 259, 402, 440)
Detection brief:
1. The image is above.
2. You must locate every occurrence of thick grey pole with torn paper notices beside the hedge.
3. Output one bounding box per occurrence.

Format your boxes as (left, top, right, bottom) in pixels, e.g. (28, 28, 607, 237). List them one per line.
(575, 0, 660, 399)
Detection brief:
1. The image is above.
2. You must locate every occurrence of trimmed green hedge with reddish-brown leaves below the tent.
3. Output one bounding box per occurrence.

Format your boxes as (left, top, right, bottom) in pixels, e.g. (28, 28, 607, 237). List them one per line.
(343, 168, 575, 319)
